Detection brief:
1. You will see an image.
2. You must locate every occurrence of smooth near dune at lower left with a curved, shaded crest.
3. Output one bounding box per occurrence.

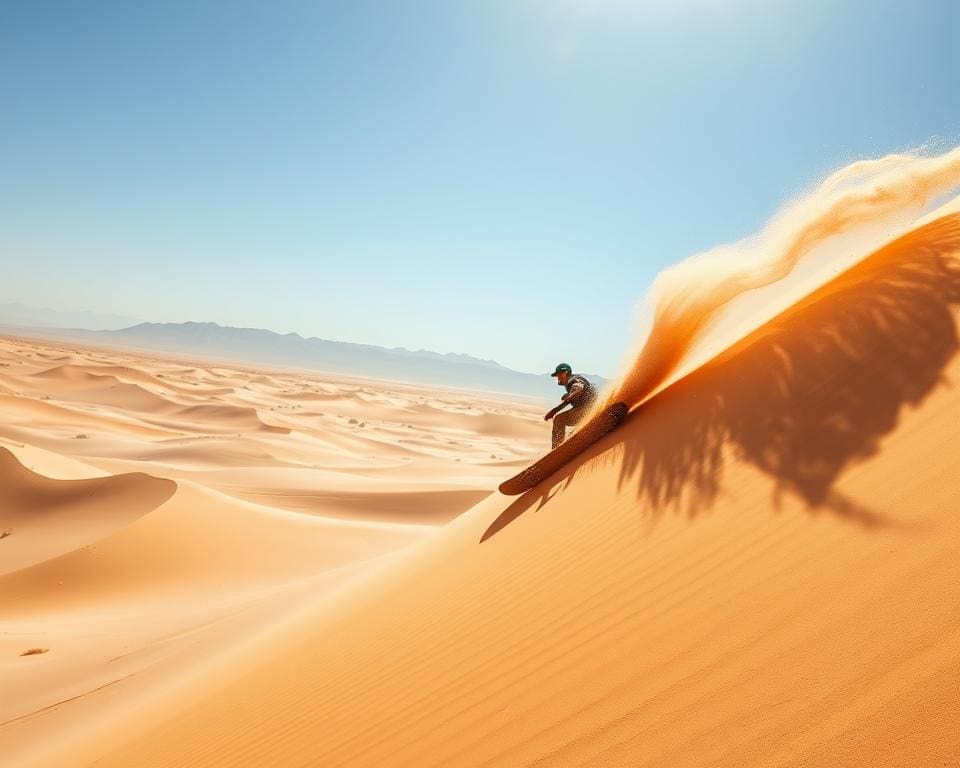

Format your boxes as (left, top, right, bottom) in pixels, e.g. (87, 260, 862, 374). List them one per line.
(0, 450, 430, 754)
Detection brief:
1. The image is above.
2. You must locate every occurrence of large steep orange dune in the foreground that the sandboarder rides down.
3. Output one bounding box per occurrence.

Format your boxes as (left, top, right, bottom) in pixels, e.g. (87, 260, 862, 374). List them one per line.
(15, 201, 960, 766)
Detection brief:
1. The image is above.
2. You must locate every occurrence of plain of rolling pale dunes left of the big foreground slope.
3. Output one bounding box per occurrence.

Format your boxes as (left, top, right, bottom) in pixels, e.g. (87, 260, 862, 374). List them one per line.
(0, 337, 549, 765)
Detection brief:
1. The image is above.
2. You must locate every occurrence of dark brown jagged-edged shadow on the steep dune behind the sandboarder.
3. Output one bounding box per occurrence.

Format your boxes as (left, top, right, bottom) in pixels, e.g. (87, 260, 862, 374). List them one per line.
(620, 215, 960, 527)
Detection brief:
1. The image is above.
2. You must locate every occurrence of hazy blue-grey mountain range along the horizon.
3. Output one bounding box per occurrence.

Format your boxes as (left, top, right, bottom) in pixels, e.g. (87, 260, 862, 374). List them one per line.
(0, 305, 606, 400)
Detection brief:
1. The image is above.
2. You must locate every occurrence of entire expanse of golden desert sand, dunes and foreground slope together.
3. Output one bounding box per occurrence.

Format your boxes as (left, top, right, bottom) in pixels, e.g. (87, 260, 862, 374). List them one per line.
(0, 153, 960, 768)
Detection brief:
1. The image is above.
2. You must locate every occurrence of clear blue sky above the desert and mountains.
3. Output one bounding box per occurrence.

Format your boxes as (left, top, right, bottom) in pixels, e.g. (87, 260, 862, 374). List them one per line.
(0, 0, 960, 375)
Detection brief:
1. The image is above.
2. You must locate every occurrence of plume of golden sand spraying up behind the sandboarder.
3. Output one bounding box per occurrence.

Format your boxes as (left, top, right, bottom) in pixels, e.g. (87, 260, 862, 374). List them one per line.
(606, 142, 960, 408)
